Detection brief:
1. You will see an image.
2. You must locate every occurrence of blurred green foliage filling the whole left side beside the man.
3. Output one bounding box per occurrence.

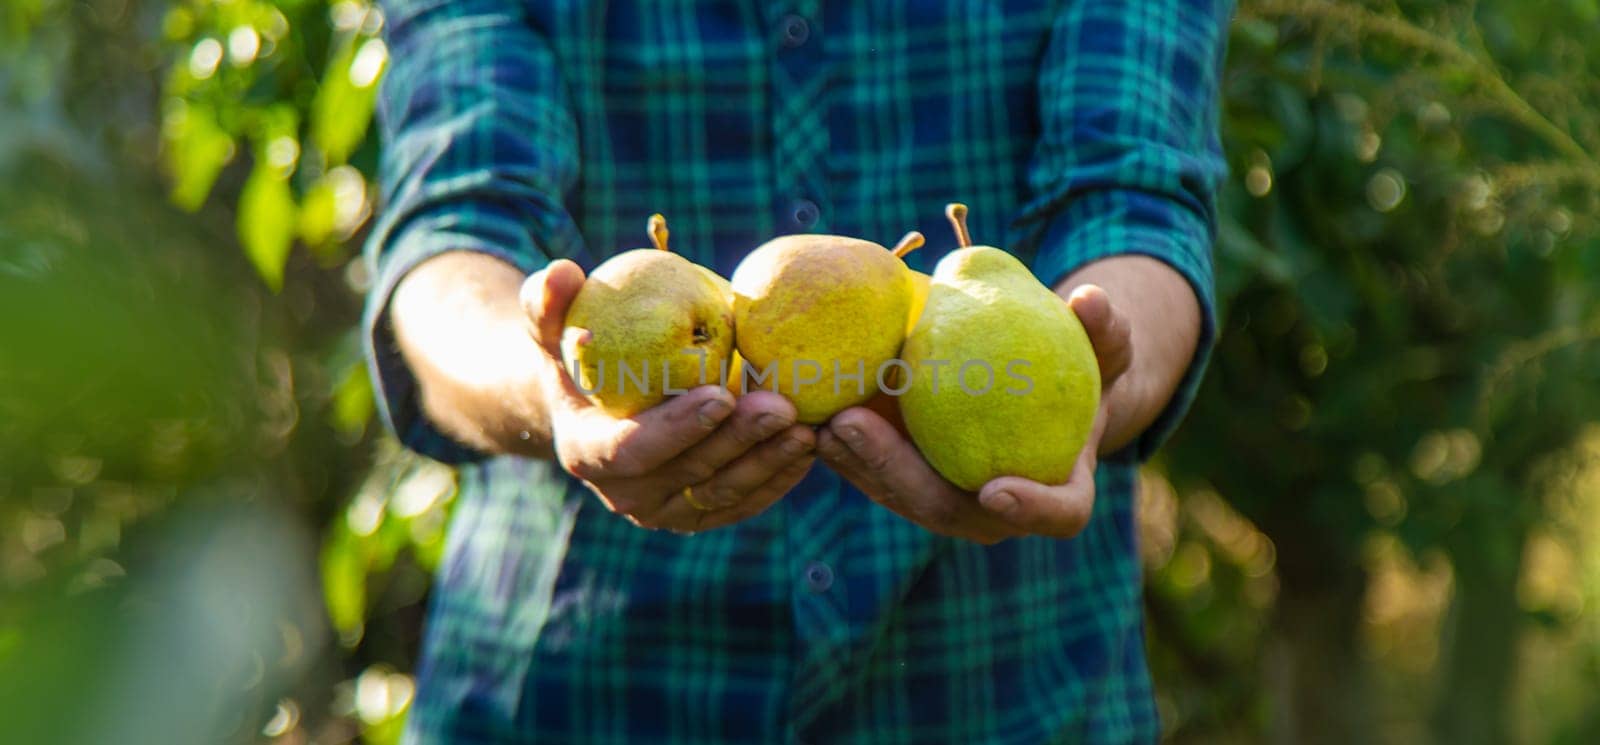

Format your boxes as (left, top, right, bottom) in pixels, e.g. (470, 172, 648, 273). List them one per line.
(0, 0, 438, 743)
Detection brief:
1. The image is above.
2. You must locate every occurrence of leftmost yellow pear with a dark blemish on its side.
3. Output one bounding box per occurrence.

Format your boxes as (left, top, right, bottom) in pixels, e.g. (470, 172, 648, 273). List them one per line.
(562, 214, 733, 417)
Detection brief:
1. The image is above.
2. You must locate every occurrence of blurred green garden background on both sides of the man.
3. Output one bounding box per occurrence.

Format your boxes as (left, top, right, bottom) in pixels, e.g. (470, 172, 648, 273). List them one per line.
(0, 0, 1600, 745)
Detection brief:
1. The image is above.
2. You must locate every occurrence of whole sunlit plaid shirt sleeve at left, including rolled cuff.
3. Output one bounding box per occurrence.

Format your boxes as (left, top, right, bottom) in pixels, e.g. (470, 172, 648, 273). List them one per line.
(363, 0, 584, 462)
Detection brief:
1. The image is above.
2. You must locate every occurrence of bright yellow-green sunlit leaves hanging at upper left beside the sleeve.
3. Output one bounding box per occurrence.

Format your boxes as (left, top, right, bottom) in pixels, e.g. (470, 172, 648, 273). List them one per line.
(162, 0, 389, 289)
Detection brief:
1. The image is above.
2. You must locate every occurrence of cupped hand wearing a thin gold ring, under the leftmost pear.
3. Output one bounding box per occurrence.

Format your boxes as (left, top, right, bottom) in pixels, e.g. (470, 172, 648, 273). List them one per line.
(522, 261, 816, 532)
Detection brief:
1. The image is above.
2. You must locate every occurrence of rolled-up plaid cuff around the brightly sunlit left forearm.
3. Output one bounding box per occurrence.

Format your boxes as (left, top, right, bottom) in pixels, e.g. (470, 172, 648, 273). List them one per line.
(363, 205, 549, 464)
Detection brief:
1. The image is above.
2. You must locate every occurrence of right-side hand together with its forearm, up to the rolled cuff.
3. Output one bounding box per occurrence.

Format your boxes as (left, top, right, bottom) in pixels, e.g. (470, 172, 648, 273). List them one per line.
(818, 257, 1198, 544)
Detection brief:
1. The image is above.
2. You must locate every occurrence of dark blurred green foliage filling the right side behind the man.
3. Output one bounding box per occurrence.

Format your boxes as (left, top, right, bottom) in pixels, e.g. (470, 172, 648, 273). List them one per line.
(1149, 0, 1600, 743)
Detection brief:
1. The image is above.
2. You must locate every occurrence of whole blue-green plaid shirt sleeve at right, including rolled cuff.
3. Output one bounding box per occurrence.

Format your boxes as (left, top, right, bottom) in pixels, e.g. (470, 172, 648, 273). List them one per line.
(1016, 0, 1234, 460)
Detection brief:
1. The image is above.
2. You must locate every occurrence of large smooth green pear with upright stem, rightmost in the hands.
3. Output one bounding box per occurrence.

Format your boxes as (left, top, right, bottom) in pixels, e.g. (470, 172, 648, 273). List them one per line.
(899, 205, 1101, 491)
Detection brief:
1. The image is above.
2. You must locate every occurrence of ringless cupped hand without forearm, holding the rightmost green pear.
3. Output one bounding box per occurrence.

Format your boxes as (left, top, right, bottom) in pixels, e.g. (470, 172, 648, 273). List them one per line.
(816, 285, 1133, 545)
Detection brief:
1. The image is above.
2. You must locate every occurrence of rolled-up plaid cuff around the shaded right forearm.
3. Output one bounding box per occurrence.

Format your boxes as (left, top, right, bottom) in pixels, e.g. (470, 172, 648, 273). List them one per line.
(1032, 189, 1216, 460)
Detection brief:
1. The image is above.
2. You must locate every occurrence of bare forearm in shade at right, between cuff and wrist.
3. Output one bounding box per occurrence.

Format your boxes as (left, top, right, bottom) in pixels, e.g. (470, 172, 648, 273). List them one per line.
(1056, 256, 1200, 452)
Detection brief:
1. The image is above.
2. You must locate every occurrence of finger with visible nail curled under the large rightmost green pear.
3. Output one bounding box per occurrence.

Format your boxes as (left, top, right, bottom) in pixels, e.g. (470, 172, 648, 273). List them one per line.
(978, 401, 1106, 539)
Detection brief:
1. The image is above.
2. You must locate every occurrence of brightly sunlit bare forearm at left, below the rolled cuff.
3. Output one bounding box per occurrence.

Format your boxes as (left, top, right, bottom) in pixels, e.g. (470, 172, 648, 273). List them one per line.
(389, 251, 555, 457)
